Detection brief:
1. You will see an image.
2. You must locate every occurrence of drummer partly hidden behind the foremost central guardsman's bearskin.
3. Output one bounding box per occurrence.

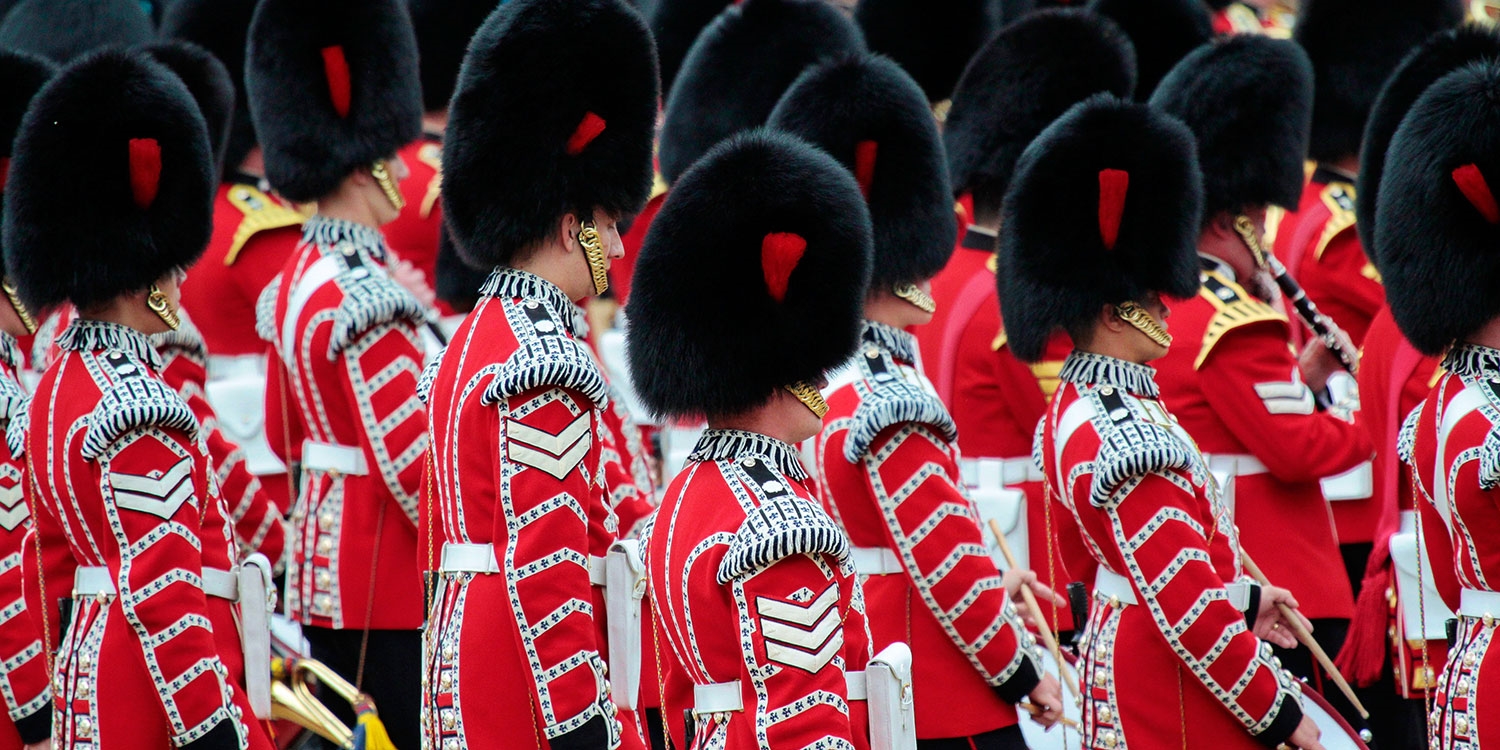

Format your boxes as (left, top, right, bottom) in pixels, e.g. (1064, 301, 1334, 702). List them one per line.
(770, 54, 1062, 749)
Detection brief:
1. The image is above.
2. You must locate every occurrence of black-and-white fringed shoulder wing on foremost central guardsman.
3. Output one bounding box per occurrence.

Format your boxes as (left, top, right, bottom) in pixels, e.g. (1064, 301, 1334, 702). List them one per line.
(719, 458, 849, 584)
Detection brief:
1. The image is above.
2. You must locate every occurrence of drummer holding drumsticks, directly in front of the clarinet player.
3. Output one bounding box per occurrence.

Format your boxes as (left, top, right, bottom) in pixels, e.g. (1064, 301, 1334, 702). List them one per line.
(999, 95, 1322, 749)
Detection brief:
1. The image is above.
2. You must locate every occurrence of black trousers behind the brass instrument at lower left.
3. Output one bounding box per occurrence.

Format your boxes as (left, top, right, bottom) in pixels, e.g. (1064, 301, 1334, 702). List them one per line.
(302, 626, 422, 750)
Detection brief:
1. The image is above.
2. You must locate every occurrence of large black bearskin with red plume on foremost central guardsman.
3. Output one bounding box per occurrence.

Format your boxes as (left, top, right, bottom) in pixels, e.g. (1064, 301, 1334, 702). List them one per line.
(627, 129, 872, 417)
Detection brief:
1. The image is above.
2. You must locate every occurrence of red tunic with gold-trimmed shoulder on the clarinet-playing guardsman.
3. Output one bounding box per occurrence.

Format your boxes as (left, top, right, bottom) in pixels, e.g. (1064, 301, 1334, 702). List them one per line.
(1157, 270, 1374, 620)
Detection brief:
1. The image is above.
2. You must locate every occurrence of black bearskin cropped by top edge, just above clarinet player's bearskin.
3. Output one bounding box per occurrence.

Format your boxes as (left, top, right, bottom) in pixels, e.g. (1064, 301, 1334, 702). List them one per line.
(1089, 0, 1214, 102)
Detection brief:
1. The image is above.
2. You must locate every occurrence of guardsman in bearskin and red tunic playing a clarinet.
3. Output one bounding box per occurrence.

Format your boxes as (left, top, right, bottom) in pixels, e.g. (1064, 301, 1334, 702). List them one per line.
(1151, 35, 1374, 720)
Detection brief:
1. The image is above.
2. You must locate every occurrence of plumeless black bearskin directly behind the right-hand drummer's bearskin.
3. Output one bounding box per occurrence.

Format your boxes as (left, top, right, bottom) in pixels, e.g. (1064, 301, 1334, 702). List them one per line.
(944, 11, 1136, 197)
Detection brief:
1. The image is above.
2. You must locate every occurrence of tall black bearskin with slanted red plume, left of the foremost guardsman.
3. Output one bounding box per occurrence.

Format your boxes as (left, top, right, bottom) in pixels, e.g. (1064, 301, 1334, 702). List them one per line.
(443, 0, 659, 269)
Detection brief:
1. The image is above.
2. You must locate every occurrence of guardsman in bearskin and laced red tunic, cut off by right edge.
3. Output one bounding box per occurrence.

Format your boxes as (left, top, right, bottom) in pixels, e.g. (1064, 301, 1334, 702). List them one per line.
(1376, 60, 1500, 750)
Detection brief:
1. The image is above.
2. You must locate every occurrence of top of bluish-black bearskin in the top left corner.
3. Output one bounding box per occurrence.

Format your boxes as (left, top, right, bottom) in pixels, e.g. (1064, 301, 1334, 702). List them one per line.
(0, 0, 155, 65)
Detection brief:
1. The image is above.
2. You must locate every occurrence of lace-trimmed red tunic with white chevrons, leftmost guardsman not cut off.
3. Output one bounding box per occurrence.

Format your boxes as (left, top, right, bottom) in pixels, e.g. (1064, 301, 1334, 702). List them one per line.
(26, 321, 270, 749)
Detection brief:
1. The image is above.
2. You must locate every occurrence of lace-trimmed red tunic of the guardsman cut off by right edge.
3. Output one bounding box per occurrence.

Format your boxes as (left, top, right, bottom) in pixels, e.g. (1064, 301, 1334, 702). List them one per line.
(1401, 345, 1500, 750)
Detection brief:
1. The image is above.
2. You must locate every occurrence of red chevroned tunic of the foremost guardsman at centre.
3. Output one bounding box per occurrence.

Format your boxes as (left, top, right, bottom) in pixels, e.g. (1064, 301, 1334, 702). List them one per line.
(647, 429, 872, 750)
